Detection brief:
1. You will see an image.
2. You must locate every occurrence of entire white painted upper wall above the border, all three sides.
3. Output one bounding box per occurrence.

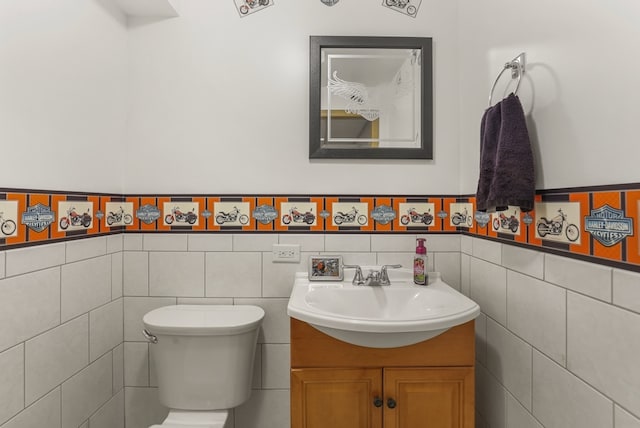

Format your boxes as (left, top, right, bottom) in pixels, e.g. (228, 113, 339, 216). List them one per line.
(0, 0, 640, 194)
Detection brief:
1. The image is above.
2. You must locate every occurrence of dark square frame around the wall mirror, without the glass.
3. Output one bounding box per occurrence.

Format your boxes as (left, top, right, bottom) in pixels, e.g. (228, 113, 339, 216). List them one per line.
(309, 36, 433, 159)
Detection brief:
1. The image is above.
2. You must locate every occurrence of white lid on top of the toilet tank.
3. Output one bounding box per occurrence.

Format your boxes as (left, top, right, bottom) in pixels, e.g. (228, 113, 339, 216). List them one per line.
(142, 305, 264, 336)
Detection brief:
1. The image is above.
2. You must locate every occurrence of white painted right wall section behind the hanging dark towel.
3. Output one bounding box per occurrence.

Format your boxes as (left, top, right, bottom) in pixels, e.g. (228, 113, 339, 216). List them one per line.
(458, 0, 640, 193)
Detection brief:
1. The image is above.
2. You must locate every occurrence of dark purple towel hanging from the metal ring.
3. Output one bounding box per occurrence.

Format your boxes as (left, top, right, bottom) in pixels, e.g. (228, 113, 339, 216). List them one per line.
(476, 93, 535, 212)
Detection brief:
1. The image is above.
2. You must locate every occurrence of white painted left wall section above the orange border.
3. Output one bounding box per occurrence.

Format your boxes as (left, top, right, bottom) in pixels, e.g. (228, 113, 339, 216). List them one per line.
(0, 0, 127, 192)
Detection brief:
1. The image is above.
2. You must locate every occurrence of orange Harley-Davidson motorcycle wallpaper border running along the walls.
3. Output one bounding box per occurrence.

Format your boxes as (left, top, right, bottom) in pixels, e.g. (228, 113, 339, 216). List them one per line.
(0, 183, 640, 272)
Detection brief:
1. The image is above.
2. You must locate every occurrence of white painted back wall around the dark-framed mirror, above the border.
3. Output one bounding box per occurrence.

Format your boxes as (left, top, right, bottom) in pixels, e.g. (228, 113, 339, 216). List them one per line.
(125, 0, 459, 194)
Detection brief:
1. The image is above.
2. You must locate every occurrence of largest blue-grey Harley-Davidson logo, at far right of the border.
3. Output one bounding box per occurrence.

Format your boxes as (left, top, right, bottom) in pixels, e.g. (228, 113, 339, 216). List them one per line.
(584, 205, 633, 247)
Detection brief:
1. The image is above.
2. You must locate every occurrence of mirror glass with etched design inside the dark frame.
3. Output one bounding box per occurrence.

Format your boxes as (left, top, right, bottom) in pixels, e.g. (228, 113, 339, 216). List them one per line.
(320, 48, 421, 148)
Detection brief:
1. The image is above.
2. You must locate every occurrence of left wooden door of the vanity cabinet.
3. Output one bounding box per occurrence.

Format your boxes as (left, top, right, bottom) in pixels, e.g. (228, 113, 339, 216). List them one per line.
(291, 369, 382, 428)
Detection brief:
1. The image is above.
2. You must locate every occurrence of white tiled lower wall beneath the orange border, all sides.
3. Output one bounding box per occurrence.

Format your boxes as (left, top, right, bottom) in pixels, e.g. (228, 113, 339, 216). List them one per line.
(0, 233, 640, 428)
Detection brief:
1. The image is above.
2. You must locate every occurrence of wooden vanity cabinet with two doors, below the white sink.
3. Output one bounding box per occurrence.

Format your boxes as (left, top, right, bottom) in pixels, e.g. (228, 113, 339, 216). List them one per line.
(291, 319, 475, 428)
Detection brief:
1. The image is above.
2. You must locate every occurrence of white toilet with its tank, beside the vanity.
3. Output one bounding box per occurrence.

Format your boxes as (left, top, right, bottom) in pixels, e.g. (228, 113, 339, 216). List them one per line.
(142, 305, 264, 428)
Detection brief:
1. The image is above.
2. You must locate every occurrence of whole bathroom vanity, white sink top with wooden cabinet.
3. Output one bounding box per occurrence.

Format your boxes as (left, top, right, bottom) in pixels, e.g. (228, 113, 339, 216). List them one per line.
(287, 267, 480, 428)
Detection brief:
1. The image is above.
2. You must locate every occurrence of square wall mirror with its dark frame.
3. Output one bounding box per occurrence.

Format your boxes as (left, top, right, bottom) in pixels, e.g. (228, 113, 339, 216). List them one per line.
(309, 36, 433, 159)
